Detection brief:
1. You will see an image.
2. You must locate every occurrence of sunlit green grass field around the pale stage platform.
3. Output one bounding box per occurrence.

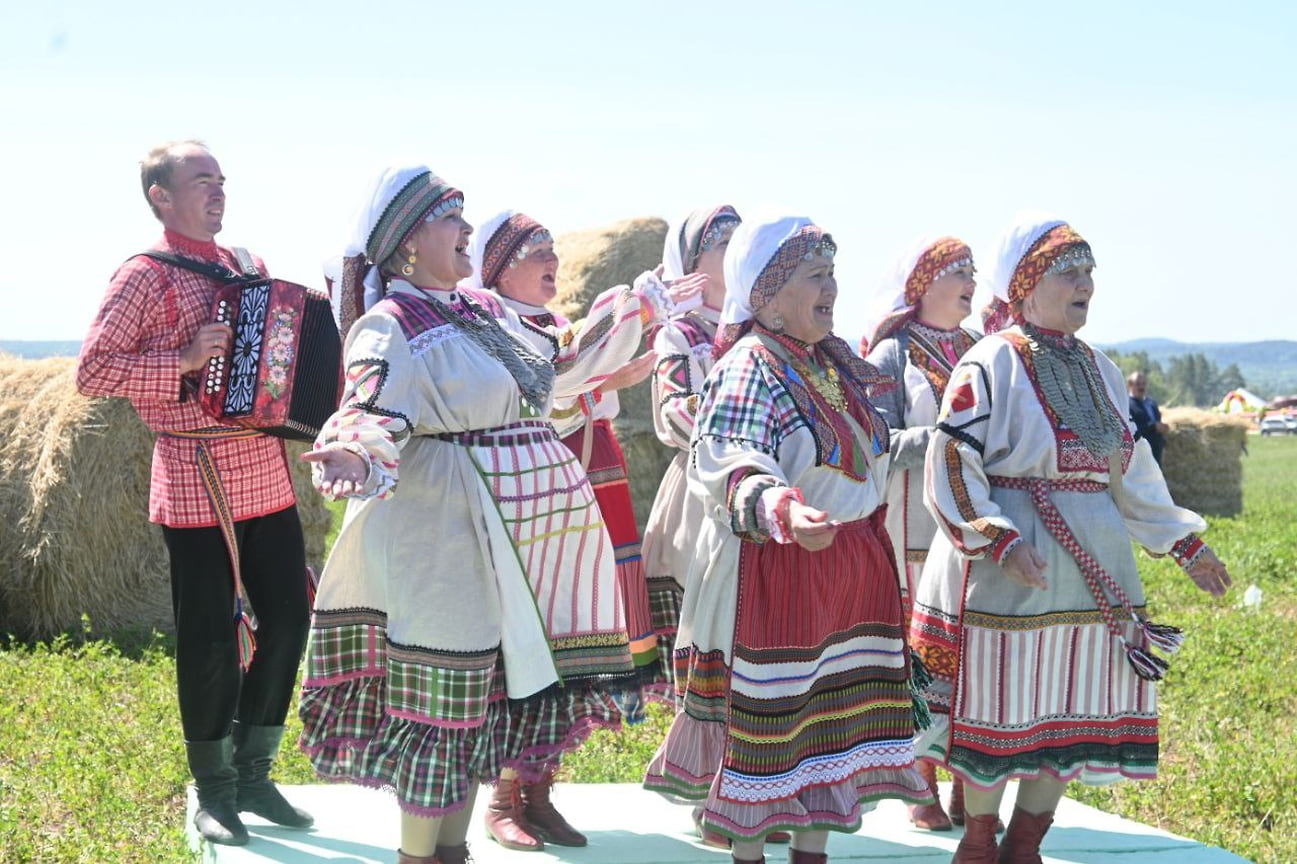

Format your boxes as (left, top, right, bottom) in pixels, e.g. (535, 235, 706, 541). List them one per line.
(0, 437, 1297, 864)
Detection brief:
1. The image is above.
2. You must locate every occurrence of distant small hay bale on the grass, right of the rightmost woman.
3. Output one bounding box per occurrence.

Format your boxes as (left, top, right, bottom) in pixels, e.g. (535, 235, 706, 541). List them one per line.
(1162, 407, 1248, 516)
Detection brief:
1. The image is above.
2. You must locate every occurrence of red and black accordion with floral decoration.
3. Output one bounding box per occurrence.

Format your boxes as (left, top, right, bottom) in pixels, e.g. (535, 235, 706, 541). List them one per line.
(198, 279, 342, 441)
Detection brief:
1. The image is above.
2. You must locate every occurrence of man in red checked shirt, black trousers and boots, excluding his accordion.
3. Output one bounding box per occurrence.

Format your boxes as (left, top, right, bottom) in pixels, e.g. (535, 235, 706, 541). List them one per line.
(77, 140, 311, 845)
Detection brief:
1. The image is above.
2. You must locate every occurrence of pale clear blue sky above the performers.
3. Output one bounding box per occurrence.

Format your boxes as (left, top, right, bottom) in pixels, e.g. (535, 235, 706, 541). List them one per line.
(0, 0, 1297, 342)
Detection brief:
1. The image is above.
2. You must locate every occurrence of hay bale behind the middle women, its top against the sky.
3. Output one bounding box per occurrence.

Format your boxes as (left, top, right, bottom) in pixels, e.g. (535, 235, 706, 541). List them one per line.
(553, 219, 674, 524)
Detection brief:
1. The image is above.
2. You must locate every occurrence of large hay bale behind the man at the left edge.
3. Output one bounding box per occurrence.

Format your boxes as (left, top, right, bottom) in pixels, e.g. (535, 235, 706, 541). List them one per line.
(0, 355, 329, 640)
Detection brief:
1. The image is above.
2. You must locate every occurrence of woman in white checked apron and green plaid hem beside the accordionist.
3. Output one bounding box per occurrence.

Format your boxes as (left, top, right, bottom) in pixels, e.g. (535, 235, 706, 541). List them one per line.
(300, 166, 648, 864)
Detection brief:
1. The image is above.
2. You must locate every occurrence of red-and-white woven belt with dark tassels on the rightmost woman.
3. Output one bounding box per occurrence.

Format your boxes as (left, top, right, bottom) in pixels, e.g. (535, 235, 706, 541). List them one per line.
(987, 476, 1184, 681)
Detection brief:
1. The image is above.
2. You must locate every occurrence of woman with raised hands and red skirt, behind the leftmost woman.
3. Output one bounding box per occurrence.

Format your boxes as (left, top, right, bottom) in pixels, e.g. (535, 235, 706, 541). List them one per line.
(462, 210, 700, 851)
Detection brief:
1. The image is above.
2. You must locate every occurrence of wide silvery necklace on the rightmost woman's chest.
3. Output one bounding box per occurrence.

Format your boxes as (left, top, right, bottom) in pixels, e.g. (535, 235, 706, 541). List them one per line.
(1022, 323, 1126, 459)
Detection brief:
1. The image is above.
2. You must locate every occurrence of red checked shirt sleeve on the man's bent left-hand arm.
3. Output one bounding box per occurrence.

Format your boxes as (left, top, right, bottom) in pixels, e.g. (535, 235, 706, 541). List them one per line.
(77, 258, 183, 402)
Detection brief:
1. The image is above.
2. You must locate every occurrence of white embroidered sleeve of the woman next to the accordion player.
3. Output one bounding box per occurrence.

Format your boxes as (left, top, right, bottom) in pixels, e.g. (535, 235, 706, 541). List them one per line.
(313, 315, 418, 498)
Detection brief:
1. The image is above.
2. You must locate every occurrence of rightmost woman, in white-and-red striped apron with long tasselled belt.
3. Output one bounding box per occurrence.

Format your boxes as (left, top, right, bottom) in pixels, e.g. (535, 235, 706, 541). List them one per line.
(912, 214, 1230, 863)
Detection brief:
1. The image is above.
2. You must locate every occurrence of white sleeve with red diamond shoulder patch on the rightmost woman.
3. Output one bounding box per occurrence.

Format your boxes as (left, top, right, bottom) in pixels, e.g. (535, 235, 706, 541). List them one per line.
(923, 362, 1019, 563)
